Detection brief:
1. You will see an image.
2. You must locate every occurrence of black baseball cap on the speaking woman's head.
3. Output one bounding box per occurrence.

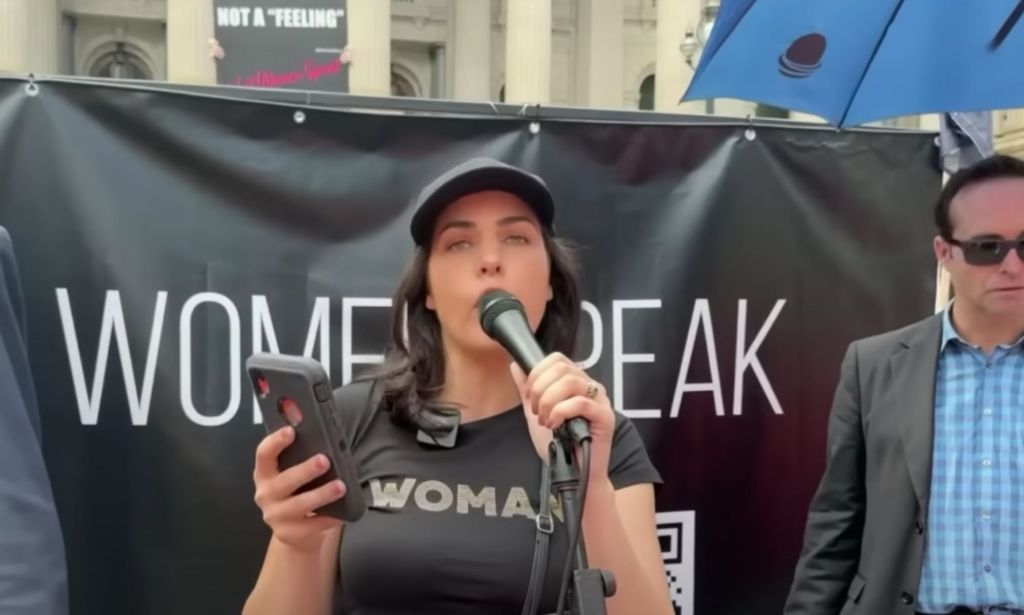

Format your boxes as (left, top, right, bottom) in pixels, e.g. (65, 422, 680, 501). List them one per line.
(410, 158, 555, 246)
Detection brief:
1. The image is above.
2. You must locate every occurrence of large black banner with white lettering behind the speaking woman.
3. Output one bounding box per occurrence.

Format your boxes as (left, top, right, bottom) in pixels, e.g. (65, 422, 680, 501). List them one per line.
(0, 80, 940, 615)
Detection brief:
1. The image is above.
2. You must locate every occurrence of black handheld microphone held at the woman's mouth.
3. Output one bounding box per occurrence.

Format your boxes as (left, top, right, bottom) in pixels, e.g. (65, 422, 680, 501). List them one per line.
(477, 291, 590, 443)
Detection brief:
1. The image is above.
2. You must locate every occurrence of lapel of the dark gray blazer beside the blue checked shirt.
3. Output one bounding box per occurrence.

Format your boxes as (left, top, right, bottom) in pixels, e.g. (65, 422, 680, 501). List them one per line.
(890, 314, 942, 511)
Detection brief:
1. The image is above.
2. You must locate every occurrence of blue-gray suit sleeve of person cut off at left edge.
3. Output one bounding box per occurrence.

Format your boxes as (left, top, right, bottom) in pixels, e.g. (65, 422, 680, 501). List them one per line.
(0, 226, 68, 615)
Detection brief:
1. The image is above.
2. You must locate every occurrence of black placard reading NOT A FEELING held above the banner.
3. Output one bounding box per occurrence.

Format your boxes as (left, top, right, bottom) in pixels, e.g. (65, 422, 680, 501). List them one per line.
(213, 0, 348, 92)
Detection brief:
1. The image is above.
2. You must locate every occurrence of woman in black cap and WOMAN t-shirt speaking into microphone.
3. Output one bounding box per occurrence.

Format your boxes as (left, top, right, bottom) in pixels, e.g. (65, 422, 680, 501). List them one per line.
(244, 159, 672, 615)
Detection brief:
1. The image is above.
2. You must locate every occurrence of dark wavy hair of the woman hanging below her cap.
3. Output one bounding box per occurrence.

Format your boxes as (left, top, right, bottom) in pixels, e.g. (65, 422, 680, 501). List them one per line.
(373, 230, 582, 429)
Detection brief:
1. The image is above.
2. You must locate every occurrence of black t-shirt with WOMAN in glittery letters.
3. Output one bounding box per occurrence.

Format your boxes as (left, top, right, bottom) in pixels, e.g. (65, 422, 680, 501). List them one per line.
(335, 380, 660, 615)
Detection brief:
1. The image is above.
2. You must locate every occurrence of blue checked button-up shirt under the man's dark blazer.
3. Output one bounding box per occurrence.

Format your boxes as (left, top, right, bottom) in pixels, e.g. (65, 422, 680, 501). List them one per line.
(918, 308, 1024, 615)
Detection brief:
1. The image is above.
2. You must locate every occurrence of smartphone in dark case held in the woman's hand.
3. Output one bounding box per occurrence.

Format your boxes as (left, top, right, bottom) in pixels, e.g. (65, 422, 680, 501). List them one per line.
(246, 353, 367, 522)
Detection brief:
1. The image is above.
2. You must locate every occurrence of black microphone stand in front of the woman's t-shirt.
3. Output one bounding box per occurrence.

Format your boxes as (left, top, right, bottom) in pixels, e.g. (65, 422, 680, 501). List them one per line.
(549, 426, 615, 615)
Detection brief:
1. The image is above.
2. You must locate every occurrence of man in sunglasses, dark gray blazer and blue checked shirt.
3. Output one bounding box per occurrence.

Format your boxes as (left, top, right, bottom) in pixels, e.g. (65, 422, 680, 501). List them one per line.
(784, 156, 1024, 615)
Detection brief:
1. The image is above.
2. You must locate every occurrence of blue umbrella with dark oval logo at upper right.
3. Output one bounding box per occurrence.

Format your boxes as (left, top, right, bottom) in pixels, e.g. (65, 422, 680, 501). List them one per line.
(683, 0, 1024, 126)
